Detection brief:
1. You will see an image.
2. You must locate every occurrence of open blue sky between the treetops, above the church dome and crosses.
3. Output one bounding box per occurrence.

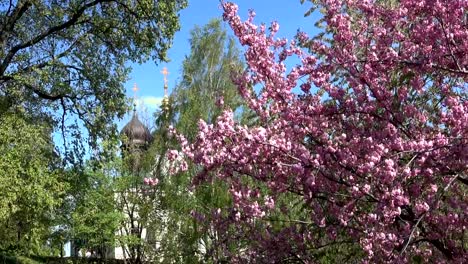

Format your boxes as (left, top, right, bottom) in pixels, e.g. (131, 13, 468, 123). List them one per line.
(119, 0, 316, 128)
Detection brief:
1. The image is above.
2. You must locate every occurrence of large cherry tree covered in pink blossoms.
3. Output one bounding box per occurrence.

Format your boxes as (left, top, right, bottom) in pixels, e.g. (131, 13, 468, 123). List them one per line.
(174, 0, 468, 263)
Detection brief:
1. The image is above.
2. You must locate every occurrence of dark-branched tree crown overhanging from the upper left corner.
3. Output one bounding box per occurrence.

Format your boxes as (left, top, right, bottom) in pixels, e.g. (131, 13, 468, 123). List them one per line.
(0, 0, 187, 153)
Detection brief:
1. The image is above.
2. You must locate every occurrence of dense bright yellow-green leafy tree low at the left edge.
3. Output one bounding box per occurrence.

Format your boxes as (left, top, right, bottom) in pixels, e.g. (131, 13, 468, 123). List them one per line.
(0, 113, 67, 254)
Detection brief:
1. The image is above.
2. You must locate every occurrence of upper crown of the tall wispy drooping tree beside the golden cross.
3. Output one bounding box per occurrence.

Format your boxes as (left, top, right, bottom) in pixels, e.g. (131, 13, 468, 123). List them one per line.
(172, 19, 243, 139)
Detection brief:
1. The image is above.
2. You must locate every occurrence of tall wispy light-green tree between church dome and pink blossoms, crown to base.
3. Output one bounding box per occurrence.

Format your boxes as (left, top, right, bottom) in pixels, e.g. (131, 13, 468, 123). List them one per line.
(147, 19, 243, 263)
